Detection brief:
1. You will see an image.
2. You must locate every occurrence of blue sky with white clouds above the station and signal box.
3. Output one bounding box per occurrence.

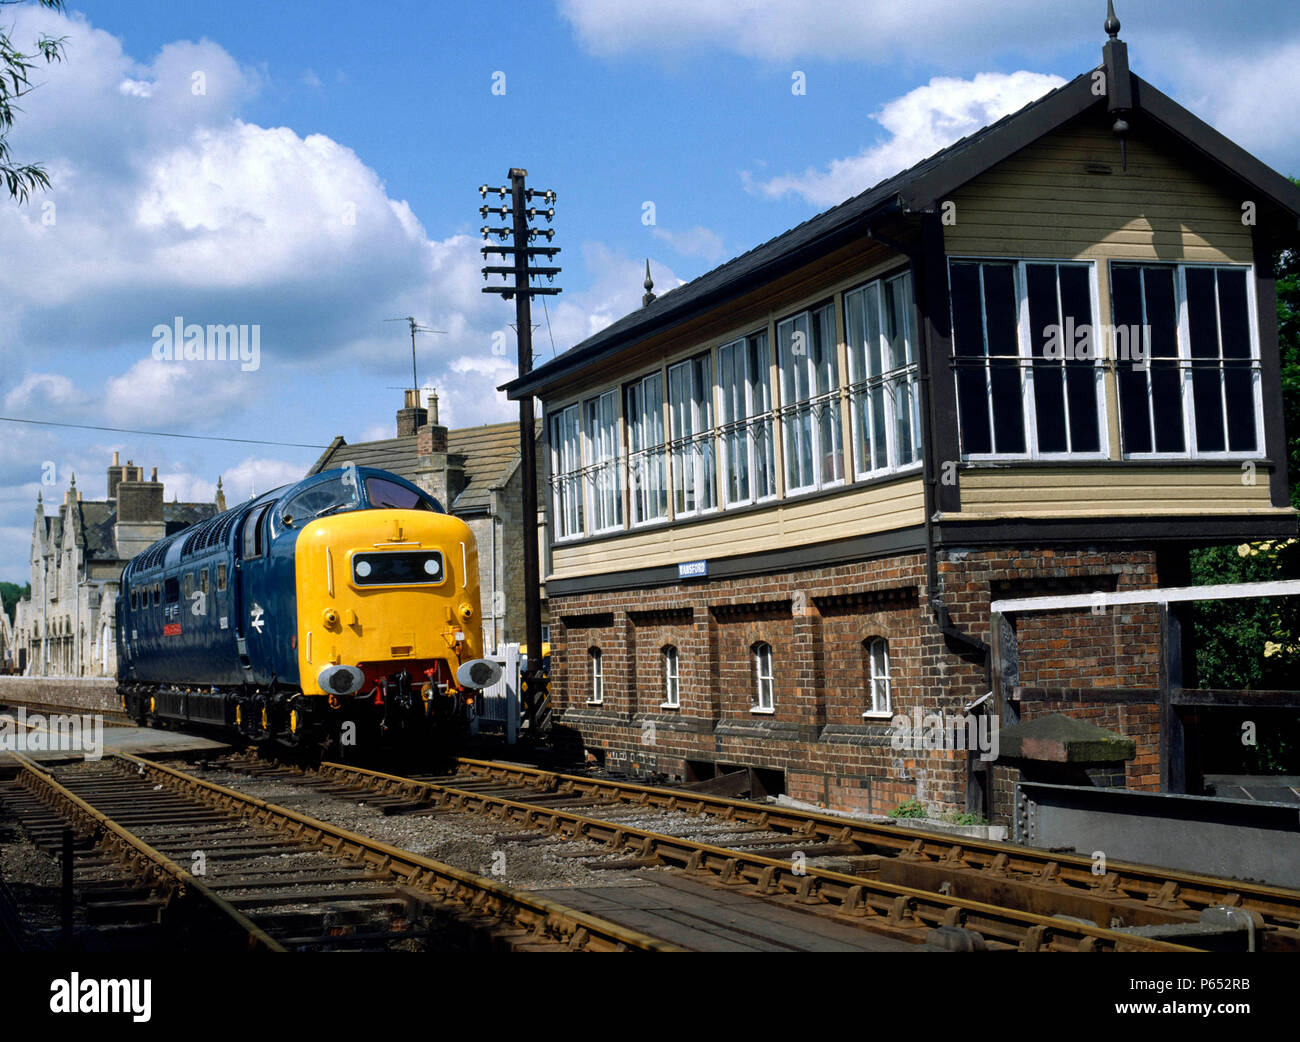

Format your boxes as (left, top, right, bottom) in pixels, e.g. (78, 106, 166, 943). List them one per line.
(0, 0, 1300, 581)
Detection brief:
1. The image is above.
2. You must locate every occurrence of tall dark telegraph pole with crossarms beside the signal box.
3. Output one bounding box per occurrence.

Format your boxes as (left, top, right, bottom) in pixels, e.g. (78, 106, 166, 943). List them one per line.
(478, 168, 560, 733)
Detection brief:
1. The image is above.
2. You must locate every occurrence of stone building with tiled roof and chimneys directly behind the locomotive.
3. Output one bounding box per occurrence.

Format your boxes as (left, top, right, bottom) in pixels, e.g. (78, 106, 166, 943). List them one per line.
(308, 390, 546, 648)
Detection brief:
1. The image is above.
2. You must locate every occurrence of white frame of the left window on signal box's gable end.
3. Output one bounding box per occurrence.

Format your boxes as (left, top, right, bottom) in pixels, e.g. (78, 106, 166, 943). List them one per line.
(948, 256, 1110, 463)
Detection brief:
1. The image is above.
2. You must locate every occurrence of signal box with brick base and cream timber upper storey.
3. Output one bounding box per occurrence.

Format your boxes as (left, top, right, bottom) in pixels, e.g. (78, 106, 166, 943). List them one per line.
(504, 12, 1300, 821)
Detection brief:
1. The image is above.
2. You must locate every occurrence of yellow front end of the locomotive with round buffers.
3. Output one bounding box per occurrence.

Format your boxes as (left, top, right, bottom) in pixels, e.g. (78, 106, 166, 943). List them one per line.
(289, 508, 501, 744)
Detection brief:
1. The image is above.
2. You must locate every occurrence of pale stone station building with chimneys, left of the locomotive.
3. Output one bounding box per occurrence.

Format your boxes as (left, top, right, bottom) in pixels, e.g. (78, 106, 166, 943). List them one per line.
(13, 452, 226, 676)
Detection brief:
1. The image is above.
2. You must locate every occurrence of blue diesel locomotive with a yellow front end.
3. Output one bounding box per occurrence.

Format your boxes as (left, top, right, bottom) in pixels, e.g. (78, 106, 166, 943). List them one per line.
(117, 465, 501, 750)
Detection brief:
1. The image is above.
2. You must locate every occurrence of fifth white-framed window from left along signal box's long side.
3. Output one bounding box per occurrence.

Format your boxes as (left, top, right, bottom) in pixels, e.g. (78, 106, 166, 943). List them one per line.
(715, 330, 776, 509)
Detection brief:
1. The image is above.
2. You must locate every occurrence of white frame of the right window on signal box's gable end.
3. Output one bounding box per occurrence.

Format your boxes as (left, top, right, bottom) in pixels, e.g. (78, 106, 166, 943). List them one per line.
(1110, 259, 1268, 460)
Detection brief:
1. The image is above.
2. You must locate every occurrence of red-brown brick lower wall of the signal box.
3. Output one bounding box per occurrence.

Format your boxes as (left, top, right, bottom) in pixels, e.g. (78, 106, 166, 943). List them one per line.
(550, 548, 1158, 820)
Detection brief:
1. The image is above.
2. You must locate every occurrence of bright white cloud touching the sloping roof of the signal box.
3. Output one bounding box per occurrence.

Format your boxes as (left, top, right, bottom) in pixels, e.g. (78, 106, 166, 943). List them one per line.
(745, 71, 1065, 207)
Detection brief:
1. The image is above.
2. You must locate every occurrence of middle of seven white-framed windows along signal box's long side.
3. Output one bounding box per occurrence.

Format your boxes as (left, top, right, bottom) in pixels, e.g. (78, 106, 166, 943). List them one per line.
(667, 351, 718, 517)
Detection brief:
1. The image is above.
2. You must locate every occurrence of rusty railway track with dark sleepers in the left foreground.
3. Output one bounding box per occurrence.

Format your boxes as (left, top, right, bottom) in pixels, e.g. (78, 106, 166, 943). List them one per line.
(0, 754, 673, 951)
